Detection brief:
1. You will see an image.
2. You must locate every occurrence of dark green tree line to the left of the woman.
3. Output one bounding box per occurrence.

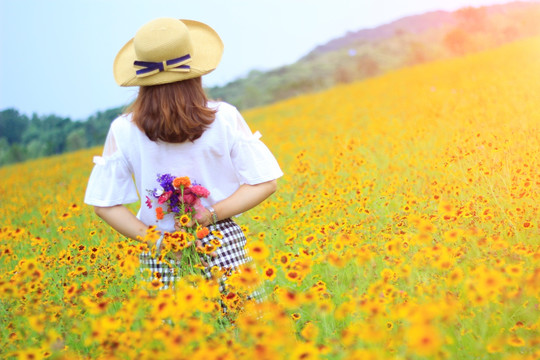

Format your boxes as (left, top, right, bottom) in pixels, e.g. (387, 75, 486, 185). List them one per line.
(0, 107, 123, 166)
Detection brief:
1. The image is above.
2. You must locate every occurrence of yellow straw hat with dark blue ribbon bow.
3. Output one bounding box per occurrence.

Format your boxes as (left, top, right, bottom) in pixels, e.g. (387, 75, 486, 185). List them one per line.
(113, 18, 223, 86)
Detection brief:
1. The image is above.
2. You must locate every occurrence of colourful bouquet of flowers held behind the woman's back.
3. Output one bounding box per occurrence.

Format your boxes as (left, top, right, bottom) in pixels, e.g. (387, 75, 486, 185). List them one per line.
(146, 174, 215, 275)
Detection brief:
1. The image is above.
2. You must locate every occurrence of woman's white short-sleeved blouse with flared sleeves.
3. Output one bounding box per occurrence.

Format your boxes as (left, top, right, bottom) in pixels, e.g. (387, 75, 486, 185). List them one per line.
(84, 102, 283, 231)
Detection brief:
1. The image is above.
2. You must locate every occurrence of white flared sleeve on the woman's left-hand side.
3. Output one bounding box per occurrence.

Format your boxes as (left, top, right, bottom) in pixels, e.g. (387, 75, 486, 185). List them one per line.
(84, 129, 139, 206)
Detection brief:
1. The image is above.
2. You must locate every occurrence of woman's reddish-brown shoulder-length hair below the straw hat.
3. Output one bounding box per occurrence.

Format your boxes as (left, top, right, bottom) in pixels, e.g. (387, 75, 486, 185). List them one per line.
(127, 77, 216, 143)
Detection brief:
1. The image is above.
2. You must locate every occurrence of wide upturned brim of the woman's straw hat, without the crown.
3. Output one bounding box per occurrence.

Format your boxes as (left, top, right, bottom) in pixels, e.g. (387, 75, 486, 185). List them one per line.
(113, 20, 223, 86)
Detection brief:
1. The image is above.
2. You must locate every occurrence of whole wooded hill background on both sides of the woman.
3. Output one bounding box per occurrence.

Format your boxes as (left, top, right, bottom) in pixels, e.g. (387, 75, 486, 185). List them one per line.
(0, 2, 540, 166)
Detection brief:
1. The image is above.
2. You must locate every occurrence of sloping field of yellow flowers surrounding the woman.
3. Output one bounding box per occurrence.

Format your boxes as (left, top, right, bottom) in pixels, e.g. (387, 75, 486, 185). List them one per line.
(0, 38, 540, 359)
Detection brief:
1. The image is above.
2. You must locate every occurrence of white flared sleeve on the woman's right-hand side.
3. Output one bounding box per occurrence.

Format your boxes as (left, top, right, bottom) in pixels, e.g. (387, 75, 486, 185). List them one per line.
(231, 112, 283, 185)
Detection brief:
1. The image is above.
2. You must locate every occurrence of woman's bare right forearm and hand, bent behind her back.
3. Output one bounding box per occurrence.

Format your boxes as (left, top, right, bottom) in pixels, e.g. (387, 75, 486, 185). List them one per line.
(190, 180, 277, 226)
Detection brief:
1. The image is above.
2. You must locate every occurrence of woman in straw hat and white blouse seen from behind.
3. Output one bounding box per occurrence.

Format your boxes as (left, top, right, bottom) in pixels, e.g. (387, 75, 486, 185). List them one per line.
(85, 18, 283, 288)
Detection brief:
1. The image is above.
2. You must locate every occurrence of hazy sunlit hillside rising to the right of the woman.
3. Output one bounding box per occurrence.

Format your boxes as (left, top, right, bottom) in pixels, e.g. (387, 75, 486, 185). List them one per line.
(208, 2, 540, 109)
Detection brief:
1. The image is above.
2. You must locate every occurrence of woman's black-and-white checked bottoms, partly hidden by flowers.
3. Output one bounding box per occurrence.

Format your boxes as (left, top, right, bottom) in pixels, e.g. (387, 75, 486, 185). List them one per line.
(139, 218, 262, 300)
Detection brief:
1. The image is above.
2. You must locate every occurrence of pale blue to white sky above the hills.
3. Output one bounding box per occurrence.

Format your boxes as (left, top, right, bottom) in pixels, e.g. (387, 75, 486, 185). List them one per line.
(0, 0, 524, 120)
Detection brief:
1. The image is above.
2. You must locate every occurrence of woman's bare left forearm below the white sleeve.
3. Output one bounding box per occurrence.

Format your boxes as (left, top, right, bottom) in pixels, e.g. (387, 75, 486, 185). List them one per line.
(94, 205, 148, 242)
